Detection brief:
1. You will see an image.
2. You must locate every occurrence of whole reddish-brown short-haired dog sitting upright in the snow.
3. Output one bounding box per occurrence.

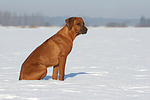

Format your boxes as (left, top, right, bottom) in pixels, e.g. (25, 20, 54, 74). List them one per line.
(19, 17, 87, 81)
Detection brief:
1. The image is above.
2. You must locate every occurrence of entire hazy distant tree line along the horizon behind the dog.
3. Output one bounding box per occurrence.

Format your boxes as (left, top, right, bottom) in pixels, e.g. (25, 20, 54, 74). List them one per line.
(0, 10, 150, 27)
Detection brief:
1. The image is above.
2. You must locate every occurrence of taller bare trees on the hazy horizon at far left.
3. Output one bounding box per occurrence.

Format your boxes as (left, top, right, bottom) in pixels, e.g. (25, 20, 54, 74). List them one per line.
(0, 10, 50, 27)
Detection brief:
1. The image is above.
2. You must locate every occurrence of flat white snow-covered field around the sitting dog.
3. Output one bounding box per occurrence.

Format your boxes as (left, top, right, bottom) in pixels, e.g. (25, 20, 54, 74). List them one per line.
(0, 27, 150, 100)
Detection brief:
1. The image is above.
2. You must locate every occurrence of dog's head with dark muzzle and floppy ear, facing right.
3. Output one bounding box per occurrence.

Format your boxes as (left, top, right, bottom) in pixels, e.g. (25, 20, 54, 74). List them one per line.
(65, 17, 88, 35)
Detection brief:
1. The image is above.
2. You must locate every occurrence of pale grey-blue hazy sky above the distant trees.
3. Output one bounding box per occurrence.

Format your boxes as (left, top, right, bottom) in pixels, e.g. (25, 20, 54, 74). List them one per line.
(0, 0, 150, 19)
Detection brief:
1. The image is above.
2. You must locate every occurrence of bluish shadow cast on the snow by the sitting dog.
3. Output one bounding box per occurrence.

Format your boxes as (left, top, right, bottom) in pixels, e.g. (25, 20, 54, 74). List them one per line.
(42, 72, 88, 80)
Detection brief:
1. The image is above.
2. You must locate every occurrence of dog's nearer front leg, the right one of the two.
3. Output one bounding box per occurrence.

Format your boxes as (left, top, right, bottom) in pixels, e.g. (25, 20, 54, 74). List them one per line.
(59, 56, 67, 81)
